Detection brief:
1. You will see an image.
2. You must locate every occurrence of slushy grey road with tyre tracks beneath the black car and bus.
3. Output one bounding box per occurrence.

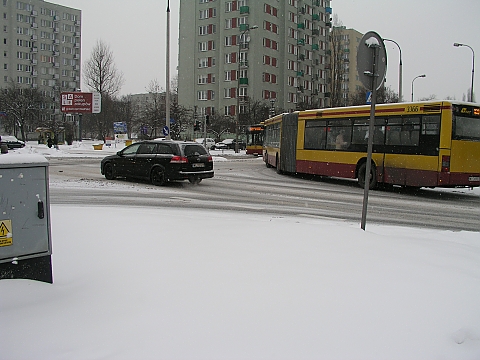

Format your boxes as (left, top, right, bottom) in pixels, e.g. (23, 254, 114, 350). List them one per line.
(49, 158, 480, 231)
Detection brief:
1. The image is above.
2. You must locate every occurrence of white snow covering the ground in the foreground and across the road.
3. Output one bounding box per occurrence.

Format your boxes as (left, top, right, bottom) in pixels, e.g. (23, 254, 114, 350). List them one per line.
(0, 143, 480, 360)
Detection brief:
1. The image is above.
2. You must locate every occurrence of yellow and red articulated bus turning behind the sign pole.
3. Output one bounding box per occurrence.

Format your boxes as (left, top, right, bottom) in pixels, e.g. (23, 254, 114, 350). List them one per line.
(263, 101, 480, 188)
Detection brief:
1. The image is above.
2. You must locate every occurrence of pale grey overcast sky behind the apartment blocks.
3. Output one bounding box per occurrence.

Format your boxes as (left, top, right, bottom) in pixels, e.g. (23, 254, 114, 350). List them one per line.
(59, 0, 480, 101)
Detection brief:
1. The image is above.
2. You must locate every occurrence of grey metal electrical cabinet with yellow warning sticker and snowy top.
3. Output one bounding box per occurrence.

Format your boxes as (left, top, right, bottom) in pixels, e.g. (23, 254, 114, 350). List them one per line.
(0, 153, 53, 283)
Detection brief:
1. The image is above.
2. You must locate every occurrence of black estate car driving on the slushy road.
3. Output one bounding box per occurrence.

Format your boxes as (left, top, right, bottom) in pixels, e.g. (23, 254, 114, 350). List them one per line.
(100, 140, 214, 186)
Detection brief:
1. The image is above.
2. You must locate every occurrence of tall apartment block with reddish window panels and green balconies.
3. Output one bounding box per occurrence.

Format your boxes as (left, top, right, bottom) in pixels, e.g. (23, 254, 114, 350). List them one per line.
(178, 0, 332, 122)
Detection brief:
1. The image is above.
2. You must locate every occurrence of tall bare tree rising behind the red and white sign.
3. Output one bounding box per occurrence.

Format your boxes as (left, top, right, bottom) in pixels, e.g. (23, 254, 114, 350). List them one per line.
(84, 40, 124, 141)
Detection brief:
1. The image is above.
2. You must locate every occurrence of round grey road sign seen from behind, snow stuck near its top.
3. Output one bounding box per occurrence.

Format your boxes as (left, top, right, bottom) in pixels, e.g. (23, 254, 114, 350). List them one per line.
(357, 31, 387, 90)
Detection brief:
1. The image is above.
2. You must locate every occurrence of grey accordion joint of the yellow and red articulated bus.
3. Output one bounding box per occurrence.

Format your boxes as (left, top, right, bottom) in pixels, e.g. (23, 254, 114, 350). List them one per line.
(277, 113, 298, 173)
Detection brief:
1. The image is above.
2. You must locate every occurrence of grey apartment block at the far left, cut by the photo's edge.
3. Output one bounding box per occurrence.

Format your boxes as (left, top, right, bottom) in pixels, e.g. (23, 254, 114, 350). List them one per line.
(0, 0, 81, 106)
